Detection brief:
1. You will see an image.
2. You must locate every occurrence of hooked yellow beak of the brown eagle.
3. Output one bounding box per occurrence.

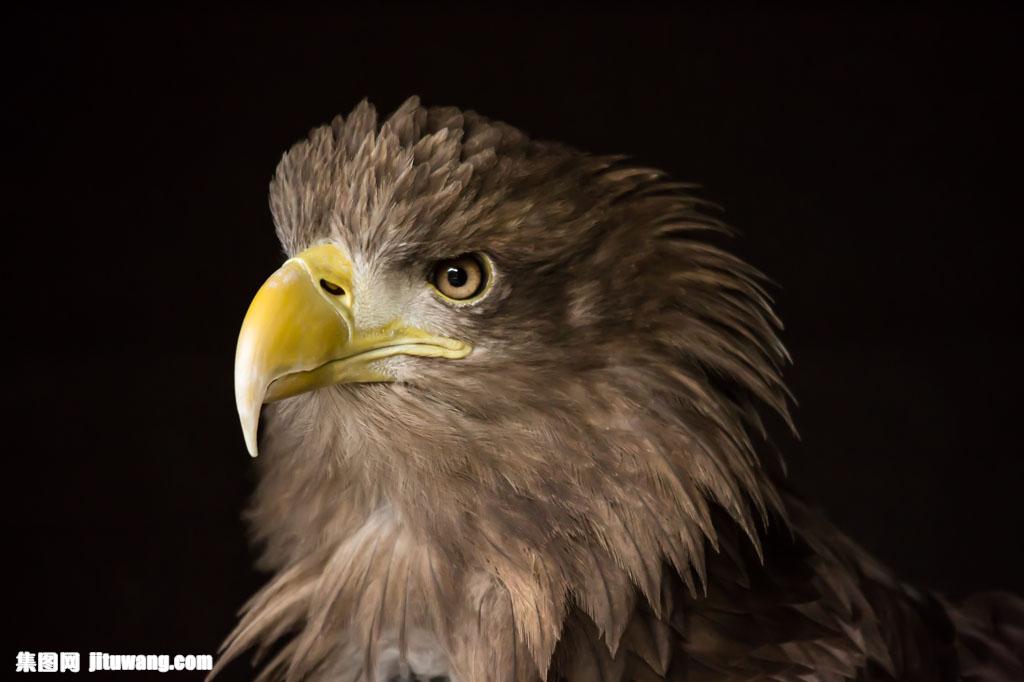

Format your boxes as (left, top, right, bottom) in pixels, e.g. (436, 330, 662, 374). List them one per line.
(234, 244, 472, 457)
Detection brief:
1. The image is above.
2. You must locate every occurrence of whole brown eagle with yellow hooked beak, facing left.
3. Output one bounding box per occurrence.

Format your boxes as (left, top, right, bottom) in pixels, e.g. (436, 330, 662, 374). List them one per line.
(218, 98, 1024, 682)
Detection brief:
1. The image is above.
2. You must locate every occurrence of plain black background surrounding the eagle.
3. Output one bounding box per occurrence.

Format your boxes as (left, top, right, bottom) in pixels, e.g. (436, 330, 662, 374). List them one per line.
(3, 5, 1024, 679)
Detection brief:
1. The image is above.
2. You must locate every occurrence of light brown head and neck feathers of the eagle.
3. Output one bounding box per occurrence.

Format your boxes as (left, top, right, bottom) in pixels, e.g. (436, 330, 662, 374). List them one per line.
(216, 98, 790, 681)
